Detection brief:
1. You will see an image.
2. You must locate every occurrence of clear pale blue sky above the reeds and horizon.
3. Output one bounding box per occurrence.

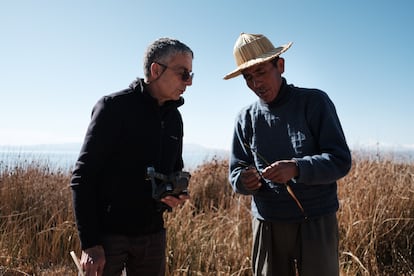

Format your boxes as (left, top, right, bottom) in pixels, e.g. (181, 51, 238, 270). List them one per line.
(0, 0, 414, 149)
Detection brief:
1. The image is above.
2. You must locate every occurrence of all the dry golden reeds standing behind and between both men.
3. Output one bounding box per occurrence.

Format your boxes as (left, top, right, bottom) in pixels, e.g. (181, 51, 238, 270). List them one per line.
(0, 154, 414, 275)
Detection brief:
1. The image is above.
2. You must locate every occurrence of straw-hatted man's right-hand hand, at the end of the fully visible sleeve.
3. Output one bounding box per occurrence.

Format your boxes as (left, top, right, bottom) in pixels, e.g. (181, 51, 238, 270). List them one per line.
(262, 160, 299, 183)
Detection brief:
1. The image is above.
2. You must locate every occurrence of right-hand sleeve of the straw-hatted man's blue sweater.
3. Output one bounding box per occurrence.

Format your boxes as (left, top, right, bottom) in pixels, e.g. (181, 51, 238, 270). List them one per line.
(294, 92, 352, 185)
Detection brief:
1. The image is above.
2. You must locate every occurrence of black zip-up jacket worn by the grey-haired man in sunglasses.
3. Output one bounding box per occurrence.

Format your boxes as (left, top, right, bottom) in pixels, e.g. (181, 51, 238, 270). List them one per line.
(71, 80, 184, 249)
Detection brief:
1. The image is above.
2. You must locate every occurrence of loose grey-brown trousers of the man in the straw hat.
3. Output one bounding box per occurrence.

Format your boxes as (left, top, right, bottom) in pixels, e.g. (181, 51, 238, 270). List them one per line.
(252, 214, 339, 276)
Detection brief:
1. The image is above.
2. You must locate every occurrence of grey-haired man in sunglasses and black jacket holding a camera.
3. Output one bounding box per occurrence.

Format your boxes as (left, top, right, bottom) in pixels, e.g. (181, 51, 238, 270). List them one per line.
(71, 38, 194, 276)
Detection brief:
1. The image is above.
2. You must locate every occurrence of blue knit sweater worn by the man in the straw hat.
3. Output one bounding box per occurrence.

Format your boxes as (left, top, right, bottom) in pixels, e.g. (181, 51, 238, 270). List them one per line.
(230, 79, 351, 222)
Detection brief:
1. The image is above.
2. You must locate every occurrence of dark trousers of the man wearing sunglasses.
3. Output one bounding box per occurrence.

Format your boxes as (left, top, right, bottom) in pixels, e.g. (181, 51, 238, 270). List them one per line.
(103, 230, 166, 276)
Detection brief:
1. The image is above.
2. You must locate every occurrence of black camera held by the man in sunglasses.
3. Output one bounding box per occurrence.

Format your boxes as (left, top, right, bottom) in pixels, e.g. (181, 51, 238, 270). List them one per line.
(147, 167, 191, 201)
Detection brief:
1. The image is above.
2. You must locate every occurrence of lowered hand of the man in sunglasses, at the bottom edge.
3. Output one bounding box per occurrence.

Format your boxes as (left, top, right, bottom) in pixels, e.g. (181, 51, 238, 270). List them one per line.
(80, 245, 105, 276)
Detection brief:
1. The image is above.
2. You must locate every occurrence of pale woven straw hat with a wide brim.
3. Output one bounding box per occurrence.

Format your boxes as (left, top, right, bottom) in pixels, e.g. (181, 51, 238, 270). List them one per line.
(224, 33, 292, 80)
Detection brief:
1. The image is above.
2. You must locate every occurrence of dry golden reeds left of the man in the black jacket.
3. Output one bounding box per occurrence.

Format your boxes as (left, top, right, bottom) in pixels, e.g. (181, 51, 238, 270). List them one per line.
(0, 162, 79, 275)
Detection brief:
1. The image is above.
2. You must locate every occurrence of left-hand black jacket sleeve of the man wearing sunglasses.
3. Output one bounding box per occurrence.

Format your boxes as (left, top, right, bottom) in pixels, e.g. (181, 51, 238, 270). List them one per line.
(70, 97, 117, 249)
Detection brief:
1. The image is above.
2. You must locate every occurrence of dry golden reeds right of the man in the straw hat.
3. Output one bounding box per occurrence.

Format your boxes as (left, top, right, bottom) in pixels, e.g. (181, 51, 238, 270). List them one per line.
(338, 152, 414, 275)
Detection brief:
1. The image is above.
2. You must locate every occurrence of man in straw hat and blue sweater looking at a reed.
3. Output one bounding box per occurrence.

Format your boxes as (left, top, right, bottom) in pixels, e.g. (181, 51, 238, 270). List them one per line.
(224, 33, 351, 276)
